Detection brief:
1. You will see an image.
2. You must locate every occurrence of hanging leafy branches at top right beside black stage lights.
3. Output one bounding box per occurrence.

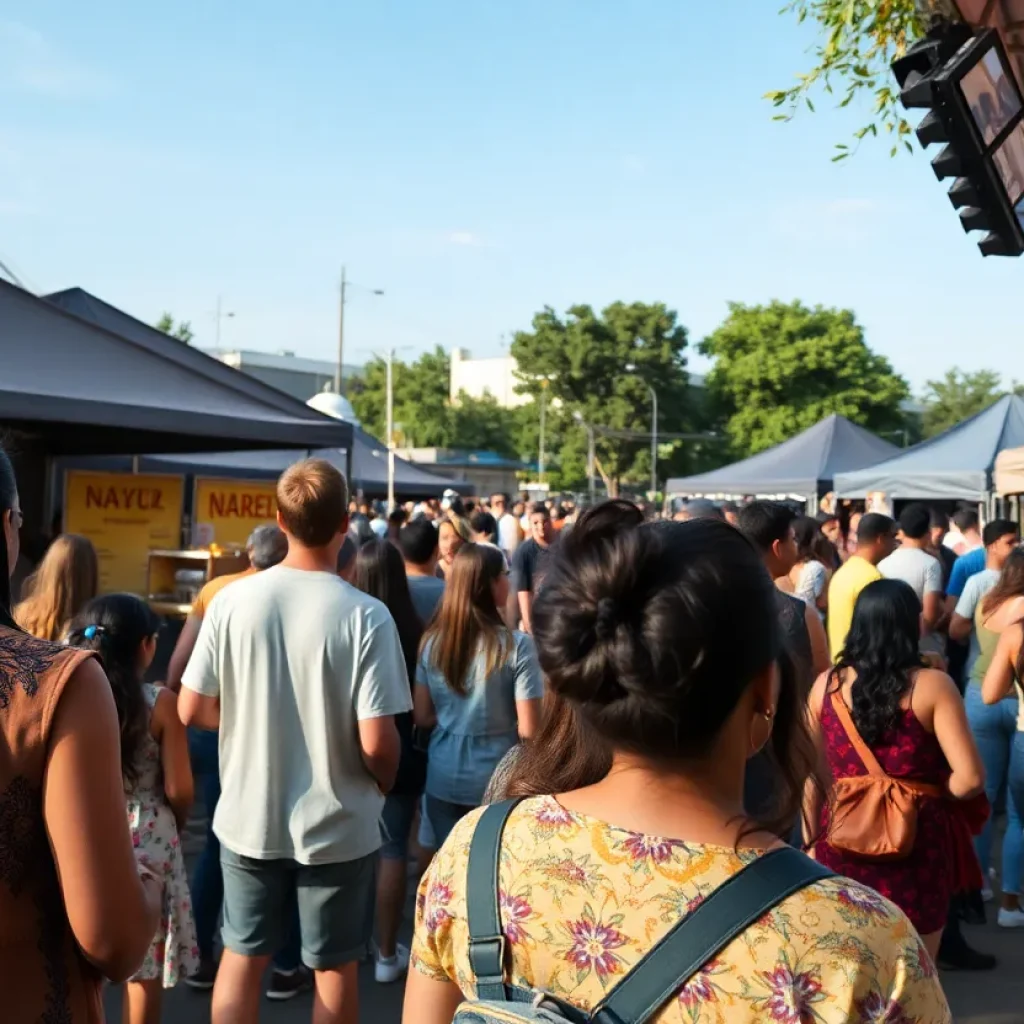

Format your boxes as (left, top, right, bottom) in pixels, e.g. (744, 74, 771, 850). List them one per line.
(765, 0, 948, 161)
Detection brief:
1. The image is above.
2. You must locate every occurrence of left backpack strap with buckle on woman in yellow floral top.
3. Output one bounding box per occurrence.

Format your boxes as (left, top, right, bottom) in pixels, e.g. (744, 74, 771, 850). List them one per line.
(466, 800, 519, 1002)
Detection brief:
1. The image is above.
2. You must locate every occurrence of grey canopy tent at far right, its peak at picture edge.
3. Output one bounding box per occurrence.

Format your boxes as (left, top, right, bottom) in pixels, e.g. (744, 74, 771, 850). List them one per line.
(836, 395, 1024, 502)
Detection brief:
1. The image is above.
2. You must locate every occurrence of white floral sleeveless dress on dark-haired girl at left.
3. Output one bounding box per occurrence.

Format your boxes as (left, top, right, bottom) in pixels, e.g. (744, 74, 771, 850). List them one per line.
(128, 683, 199, 988)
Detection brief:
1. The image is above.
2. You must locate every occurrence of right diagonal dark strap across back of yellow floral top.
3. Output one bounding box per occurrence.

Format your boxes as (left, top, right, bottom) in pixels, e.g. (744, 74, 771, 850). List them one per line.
(591, 846, 833, 1024)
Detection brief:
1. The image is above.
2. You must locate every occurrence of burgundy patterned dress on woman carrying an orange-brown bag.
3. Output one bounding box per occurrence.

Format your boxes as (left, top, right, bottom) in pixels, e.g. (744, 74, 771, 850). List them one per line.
(815, 694, 956, 935)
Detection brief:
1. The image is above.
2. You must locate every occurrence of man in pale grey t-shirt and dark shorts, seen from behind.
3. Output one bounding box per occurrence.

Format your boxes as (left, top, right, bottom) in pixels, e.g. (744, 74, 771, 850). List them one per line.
(179, 460, 412, 1024)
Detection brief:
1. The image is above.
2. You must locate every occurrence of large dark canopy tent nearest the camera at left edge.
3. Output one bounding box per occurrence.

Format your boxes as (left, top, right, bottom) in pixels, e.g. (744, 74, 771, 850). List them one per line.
(0, 280, 352, 539)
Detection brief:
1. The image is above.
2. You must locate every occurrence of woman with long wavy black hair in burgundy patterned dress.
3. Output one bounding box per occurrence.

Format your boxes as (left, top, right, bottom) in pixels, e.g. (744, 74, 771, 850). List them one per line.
(805, 580, 985, 957)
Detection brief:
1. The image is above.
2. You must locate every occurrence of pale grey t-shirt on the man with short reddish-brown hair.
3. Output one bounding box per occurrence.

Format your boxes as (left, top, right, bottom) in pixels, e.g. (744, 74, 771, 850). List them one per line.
(181, 565, 413, 864)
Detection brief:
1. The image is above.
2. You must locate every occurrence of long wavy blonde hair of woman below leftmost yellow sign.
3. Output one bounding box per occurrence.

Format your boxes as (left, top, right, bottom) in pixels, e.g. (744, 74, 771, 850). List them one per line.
(14, 534, 99, 641)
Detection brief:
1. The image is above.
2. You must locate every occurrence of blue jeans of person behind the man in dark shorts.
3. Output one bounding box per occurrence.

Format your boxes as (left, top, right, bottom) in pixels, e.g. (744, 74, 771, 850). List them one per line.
(188, 729, 302, 971)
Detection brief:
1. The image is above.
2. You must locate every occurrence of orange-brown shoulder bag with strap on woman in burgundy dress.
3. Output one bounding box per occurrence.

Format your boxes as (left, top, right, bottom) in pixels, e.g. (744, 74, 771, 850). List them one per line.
(827, 690, 944, 860)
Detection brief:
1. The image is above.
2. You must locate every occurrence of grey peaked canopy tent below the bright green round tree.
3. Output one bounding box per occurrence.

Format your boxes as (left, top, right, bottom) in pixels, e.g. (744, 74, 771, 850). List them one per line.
(666, 414, 899, 499)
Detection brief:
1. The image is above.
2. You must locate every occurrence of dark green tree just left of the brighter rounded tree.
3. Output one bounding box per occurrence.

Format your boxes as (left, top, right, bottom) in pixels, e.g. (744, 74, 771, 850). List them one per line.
(511, 302, 691, 495)
